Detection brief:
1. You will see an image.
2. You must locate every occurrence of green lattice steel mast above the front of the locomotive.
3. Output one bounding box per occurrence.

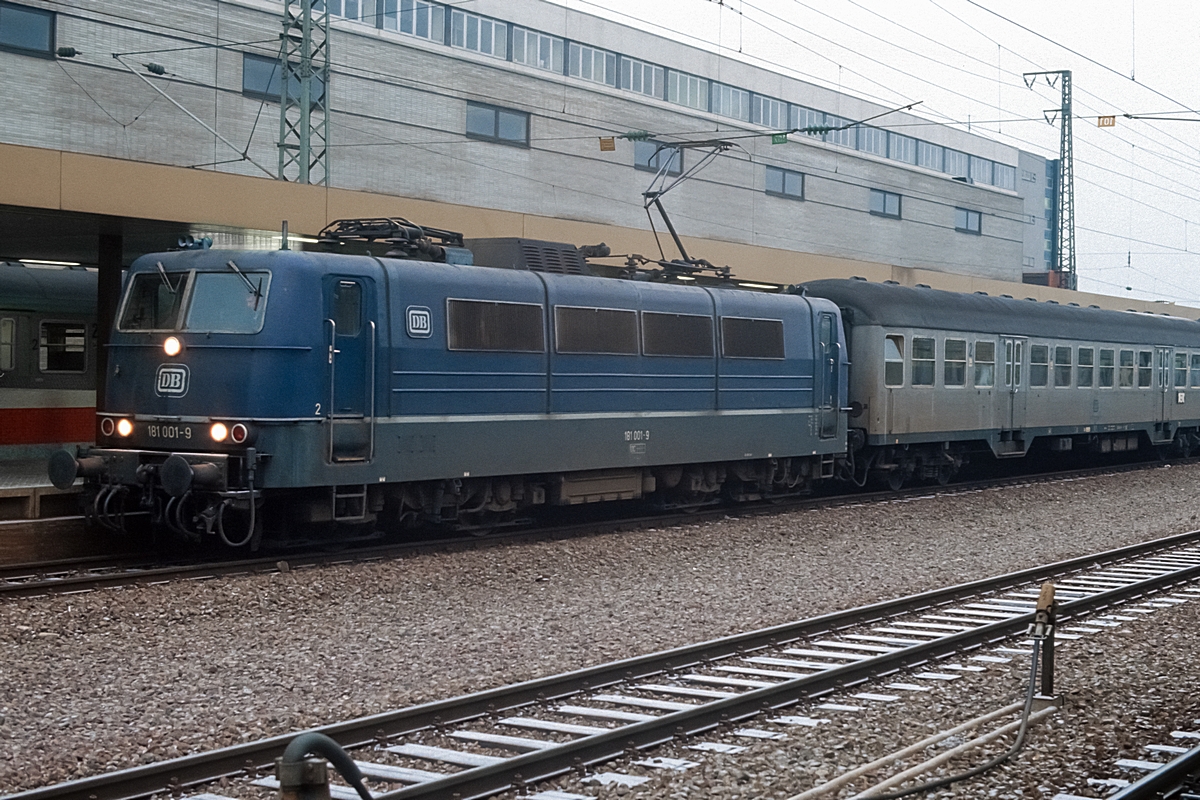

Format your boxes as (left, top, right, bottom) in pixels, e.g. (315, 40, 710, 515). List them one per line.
(278, 0, 329, 185)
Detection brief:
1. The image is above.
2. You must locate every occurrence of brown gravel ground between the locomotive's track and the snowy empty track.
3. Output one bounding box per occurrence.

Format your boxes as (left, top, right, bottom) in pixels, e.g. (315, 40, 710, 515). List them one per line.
(0, 465, 1200, 796)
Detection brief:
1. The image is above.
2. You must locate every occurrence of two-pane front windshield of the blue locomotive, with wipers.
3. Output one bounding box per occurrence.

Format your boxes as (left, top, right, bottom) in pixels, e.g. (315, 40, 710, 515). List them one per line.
(119, 267, 271, 333)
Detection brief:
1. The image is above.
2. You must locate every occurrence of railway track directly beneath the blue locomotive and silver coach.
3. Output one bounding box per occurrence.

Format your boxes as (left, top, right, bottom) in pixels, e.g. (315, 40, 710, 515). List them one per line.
(0, 463, 1180, 599)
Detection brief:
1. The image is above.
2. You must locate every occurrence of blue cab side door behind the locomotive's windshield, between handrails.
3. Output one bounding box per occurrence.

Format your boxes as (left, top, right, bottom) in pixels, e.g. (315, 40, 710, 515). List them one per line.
(325, 276, 376, 462)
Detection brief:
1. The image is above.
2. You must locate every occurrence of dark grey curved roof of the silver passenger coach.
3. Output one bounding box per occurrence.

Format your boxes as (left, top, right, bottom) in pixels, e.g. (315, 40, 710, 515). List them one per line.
(803, 278, 1200, 347)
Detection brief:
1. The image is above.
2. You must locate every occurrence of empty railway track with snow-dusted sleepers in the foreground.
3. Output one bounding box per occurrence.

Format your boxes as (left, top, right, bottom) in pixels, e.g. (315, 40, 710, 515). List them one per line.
(12, 531, 1200, 800)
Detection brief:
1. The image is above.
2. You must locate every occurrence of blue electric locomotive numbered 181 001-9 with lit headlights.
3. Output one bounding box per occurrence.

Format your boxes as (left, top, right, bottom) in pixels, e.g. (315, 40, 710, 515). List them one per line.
(50, 219, 848, 547)
